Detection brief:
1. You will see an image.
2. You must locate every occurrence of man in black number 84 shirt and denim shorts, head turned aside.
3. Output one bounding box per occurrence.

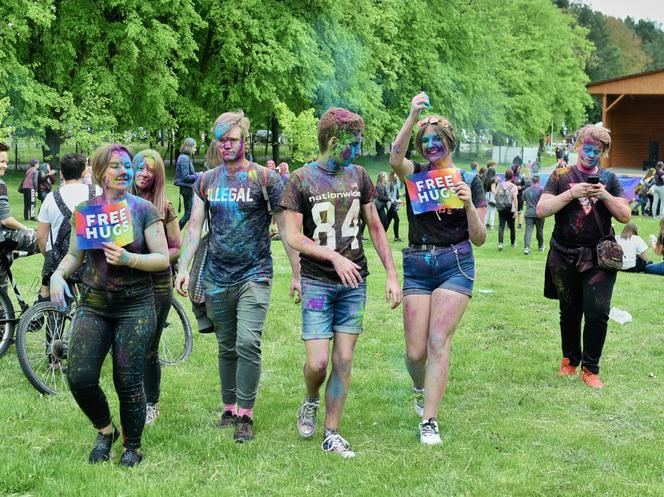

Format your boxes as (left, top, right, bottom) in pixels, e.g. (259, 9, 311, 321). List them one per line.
(281, 108, 401, 457)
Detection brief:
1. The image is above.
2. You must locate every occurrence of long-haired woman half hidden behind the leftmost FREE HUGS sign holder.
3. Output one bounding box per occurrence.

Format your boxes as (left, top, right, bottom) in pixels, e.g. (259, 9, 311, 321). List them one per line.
(132, 149, 181, 425)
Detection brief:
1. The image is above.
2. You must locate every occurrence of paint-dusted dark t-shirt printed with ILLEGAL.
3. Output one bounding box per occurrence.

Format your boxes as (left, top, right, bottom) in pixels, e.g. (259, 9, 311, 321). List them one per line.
(194, 163, 284, 286)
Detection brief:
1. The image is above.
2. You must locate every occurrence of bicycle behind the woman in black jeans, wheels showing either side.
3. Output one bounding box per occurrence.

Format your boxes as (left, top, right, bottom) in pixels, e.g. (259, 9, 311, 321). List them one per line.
(16, 296, 193, 395)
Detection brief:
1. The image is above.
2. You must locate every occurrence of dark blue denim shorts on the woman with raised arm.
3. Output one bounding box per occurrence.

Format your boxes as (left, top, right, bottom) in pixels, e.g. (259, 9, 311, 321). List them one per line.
(403, 240, 475, 297)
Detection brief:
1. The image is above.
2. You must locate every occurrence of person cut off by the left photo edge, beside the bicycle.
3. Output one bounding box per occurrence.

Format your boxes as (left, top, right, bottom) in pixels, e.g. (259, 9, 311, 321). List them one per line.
(0, 142, 39, 291)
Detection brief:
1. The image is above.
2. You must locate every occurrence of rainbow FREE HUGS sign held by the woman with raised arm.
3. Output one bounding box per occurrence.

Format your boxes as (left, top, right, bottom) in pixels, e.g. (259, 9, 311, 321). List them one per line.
(405, 168, 463, 214)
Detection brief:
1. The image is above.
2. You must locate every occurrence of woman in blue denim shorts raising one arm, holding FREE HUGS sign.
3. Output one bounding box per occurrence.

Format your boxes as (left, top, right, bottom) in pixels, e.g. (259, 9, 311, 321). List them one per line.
(390, 93, 486, 445)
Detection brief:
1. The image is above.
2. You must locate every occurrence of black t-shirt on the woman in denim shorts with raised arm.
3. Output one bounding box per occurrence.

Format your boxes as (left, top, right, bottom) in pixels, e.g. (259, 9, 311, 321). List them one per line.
(406, 162, 487, 247)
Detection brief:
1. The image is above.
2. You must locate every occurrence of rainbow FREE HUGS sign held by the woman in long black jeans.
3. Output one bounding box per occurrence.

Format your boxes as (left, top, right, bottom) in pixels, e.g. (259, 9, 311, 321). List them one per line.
(74, 200, 134, 250)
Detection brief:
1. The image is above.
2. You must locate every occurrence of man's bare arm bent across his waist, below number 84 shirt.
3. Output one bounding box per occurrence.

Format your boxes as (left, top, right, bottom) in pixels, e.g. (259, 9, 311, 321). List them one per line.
(280, 209, 362, 288)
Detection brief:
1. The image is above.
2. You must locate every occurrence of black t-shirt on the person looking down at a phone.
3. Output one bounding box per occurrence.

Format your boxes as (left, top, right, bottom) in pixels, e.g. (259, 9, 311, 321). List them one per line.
(543, 166, 625, 247)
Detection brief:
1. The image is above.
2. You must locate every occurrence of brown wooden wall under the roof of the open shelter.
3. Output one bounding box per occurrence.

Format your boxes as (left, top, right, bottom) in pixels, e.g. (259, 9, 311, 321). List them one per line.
(604, 95, 664, 169)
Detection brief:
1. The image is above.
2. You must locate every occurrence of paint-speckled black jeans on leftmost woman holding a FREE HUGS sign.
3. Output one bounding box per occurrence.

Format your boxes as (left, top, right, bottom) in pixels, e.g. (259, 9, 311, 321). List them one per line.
(67, 280, 156, 449)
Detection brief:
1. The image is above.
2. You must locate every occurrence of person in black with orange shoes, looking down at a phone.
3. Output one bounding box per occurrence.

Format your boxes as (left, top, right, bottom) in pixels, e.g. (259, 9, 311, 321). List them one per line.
(537, 124, 631, 388)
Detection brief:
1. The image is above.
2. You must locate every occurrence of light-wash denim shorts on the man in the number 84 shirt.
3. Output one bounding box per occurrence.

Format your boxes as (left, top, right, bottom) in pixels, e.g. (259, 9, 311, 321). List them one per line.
(300, 277, 367, 340)
